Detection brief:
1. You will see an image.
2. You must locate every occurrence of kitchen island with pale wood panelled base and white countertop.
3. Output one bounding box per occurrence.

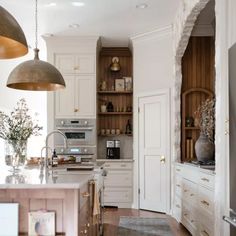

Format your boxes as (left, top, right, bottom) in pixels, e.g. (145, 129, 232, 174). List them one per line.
(0, 167, 103, 236)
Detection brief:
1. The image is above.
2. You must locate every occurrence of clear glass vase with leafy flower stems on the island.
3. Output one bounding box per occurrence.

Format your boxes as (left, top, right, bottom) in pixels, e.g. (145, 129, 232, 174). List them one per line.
(0, 98, 42, 171)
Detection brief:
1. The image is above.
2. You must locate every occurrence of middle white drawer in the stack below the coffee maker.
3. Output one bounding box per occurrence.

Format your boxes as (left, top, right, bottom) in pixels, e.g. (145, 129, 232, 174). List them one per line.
(104, 170, 133, 187)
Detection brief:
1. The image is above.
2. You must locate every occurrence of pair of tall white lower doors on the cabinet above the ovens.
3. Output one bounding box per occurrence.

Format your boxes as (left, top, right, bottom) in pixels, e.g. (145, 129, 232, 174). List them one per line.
(55, 75, 96, 118)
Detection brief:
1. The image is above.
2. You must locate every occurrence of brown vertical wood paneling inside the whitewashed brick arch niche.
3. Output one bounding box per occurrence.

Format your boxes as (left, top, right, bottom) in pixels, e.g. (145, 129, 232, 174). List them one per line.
(181, 37, 215, 161)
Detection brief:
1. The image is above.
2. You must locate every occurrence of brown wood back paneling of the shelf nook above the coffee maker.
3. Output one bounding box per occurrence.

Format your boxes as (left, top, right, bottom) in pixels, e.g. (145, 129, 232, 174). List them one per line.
(97, 48, 133, 134)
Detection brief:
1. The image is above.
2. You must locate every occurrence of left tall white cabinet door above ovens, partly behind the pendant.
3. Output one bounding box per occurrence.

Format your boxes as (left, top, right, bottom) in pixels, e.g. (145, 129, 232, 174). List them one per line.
(55, 75, 77, 118)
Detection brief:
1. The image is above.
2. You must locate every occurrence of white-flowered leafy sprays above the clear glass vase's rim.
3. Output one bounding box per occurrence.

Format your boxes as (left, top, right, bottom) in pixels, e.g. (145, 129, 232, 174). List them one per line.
(0, 98, 42, 141)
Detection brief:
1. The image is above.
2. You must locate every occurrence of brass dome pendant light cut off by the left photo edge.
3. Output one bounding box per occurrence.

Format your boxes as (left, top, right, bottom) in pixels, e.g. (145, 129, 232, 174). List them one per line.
(0, 6, 28, 59)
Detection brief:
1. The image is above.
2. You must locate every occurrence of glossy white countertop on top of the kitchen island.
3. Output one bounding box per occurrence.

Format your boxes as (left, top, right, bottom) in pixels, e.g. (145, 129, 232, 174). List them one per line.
(0, 166, 101, 189)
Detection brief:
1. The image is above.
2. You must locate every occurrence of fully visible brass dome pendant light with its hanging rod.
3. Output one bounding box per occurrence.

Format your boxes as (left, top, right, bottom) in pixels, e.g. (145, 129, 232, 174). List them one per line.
(7, 0, 66, 91)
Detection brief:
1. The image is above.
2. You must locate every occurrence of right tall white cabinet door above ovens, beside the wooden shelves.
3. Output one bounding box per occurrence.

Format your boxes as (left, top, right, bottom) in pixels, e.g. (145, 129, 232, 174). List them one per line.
(75, 75, 96, 118)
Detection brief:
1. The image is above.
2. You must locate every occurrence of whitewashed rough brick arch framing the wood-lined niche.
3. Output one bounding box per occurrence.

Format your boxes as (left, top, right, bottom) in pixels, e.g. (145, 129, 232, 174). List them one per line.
(173, 0, 210, 161)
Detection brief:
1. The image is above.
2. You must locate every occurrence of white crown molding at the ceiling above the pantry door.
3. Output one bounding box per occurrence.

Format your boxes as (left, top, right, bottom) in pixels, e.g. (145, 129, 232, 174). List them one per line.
(130, 25, 173, 43)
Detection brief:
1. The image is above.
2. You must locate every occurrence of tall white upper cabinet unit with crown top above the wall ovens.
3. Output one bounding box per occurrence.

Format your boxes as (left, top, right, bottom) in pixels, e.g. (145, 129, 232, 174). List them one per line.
(44, 36, 100, 127)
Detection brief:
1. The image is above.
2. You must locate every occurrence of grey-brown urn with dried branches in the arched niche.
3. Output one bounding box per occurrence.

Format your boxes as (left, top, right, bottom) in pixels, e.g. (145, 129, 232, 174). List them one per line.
(195, 98, 215, 162)
